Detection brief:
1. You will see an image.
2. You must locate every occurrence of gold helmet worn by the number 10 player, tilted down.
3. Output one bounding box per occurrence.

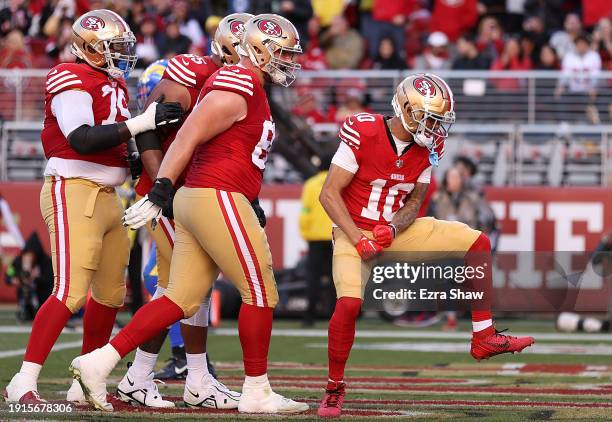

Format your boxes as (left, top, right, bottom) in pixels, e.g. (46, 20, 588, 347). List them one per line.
(391, 74, 455, 160)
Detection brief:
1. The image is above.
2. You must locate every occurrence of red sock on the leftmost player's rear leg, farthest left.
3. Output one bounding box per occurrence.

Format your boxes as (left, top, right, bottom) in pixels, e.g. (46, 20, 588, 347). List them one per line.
(23, 296, 72, 365)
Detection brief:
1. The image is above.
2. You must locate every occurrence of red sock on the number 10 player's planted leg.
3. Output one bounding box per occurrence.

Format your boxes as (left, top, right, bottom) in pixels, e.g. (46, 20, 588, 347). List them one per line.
(327, 297, 361, 382)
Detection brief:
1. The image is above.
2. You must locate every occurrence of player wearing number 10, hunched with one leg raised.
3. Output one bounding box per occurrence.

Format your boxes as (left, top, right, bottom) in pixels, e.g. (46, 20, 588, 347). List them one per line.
(318, 74, 534, 417)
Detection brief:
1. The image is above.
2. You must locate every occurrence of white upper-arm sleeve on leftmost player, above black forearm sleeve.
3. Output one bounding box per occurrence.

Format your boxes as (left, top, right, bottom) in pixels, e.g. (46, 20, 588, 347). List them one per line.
(51, 89, 95, 139)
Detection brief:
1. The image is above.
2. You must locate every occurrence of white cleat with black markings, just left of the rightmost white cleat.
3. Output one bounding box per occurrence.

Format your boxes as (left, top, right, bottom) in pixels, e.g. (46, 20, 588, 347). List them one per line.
(183, 374, 240, 409)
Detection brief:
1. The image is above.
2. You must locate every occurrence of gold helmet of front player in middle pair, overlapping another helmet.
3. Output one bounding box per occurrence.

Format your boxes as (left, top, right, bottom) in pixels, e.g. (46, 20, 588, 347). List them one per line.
(240, 14, 302, 86)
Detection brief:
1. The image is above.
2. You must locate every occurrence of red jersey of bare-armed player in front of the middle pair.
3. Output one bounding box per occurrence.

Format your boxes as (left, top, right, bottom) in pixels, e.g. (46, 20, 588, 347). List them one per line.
(185, 66, 274, 201)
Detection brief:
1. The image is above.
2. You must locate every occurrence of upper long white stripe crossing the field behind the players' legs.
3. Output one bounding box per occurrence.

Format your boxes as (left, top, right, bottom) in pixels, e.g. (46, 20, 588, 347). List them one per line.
(0, 325, 612, 341)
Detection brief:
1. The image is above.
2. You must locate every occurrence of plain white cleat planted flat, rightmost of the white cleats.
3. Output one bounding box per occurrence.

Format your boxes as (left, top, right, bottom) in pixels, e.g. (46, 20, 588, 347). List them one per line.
(238, 381, 308, 413)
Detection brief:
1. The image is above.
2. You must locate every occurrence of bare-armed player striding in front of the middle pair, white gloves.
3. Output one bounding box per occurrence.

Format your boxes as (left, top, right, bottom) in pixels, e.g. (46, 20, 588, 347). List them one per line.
(71, 14, 308, 413)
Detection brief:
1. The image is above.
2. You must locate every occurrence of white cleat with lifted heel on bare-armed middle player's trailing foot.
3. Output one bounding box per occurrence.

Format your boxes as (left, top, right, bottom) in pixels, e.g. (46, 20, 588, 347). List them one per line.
(68, 349, 113, 412)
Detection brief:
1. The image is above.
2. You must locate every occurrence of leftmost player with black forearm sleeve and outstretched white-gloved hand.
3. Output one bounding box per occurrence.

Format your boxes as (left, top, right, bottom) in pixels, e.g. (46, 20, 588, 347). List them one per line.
(5, 10, 182, 403)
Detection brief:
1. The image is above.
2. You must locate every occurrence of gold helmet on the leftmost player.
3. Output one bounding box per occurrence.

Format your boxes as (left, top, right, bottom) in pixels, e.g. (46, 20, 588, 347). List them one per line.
(71, 9, 138, 78)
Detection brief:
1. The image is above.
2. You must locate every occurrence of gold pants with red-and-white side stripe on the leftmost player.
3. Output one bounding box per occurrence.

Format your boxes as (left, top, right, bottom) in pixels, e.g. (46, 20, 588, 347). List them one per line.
(40, 177, 130, 312)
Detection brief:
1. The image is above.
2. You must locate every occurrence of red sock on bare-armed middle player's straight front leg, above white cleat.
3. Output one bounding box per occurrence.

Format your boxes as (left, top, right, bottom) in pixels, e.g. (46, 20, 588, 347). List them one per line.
(238, 303, 273, 377)
